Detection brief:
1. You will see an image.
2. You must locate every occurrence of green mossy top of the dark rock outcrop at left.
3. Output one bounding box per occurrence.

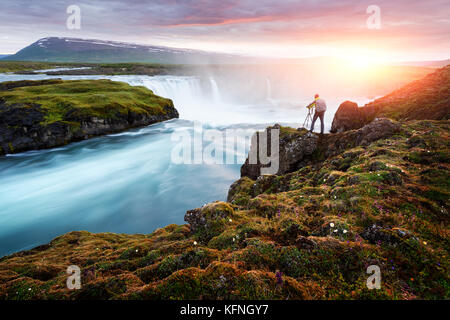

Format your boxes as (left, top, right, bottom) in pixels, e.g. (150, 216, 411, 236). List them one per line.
(0, 80, 173, 125)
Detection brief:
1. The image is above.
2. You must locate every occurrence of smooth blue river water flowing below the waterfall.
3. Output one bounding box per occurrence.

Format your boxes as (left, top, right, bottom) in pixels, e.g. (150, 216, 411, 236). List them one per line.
(0, 120, 260, 255)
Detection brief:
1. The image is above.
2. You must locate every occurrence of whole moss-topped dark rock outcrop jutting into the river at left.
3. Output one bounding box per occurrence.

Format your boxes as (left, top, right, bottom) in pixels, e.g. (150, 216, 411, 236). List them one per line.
(0, 79, 178, 155)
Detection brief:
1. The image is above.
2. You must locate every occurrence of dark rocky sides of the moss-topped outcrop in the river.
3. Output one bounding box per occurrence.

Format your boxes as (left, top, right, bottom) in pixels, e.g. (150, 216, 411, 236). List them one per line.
(0, 80, 179, 155)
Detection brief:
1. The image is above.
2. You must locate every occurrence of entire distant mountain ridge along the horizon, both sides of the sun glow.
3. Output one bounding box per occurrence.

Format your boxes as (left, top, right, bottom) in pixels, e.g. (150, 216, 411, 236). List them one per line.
(4, 37, 450, 68)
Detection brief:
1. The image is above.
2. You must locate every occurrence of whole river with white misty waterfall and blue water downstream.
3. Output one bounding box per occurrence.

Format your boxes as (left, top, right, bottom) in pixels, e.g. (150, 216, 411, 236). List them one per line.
(0, 74, 372, 256)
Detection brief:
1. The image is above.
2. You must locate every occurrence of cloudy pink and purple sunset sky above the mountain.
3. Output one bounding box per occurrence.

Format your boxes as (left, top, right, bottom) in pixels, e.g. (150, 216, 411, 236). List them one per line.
(0, 0, 450, 61)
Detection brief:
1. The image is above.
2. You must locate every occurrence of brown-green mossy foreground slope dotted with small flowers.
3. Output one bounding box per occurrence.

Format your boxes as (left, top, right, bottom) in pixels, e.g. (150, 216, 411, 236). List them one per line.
(0, 121, 450, 299)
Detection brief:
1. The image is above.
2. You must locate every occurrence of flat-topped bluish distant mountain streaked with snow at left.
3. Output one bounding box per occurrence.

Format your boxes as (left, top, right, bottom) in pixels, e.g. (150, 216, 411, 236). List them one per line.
(5, 37, 254, 64)
